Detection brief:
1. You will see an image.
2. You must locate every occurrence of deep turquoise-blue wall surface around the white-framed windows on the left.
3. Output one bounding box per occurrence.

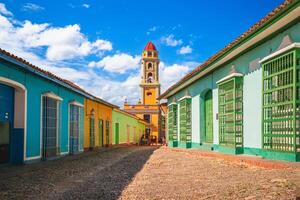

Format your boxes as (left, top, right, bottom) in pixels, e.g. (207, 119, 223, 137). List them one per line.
(0, 59, 84, 159)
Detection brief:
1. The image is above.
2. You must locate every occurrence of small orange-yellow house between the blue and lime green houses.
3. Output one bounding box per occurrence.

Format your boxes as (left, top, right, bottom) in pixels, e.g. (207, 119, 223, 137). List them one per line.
(84, 97, 117, 150)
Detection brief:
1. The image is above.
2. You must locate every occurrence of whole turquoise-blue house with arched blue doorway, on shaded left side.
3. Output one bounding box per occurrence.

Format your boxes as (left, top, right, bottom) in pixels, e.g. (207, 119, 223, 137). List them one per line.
(0, 49, 87, 164)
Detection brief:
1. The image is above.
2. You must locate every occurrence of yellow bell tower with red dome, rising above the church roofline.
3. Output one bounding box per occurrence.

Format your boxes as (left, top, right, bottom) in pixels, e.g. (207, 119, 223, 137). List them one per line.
(140, 42, 160, 105)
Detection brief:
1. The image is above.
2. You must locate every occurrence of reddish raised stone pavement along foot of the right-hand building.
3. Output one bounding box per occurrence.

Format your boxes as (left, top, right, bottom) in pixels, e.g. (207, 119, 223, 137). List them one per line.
(164, 147, 300, 170)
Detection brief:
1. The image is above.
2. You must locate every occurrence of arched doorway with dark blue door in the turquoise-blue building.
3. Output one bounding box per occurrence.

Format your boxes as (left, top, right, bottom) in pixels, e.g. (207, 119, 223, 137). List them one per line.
(0, 77, 26, 164)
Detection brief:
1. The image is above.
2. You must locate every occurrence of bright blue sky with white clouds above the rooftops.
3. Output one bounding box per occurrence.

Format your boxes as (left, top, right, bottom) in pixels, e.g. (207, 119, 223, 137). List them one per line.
(0, 0, 282, 105)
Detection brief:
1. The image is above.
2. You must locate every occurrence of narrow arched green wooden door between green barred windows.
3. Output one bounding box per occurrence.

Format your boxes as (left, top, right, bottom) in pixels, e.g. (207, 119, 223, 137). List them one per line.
(204, 90, 213, 143)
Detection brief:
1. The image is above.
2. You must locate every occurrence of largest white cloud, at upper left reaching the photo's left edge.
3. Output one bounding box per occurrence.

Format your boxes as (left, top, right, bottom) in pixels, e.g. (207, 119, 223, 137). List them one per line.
(0, 12, 112, 61)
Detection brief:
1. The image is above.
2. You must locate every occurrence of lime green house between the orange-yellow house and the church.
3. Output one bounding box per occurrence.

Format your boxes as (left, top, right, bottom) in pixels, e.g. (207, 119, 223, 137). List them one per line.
(112, 108, 148, 145)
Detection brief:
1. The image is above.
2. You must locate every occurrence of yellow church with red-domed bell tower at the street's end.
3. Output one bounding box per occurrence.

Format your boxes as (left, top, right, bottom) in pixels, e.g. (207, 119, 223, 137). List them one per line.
(124, 42, 162, 141)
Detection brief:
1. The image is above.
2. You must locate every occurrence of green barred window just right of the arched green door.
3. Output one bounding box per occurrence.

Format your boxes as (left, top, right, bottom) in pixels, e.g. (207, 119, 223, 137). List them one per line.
(218, 76, 243, 148)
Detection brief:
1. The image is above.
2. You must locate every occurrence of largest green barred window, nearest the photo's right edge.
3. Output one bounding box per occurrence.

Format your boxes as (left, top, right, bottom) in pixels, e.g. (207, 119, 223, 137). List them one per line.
(262, 50, 300, 153)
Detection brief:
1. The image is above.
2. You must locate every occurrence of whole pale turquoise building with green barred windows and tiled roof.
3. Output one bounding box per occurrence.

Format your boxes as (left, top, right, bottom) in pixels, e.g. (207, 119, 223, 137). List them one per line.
(160, 1, 300, 161)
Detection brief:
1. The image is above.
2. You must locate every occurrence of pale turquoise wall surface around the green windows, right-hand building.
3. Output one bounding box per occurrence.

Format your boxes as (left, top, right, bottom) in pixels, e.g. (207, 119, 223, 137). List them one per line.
(168, 22, 300, 149)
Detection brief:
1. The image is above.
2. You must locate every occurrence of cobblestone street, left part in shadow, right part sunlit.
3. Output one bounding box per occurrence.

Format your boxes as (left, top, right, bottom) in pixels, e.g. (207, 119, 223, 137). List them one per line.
(0, 147, 300, 200)
